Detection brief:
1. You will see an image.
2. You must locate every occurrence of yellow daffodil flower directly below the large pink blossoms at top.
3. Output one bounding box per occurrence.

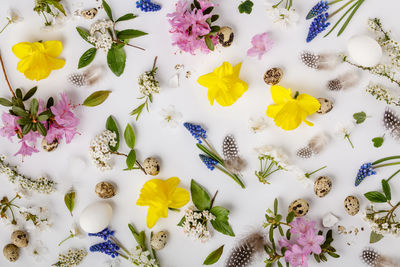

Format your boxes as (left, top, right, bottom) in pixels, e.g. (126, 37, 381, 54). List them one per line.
(197, 62, 249, 107)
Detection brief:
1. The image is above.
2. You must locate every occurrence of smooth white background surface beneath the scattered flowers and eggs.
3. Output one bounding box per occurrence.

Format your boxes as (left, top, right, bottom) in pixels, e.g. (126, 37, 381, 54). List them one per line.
(0, 0, 400, 267)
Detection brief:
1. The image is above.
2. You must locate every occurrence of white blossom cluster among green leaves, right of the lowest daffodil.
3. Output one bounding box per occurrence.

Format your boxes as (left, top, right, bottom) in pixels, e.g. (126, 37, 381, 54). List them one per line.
(182, 206, 215, 242)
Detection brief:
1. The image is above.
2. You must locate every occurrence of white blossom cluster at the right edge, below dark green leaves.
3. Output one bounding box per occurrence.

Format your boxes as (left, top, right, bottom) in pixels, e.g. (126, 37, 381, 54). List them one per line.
(363, 205, 400, 237)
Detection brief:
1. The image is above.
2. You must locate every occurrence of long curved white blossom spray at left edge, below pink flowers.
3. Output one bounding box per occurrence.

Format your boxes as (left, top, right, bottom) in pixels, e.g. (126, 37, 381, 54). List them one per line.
(0, 155, 56, 194)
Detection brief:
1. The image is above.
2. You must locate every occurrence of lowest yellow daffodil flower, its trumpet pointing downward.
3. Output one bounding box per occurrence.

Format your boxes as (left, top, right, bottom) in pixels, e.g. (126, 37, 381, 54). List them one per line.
(136, 177, 190, 228)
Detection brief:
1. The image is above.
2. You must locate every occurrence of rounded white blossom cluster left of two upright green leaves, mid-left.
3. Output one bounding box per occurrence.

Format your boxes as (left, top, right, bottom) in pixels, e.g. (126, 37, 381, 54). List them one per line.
(89, 130, 117, 171)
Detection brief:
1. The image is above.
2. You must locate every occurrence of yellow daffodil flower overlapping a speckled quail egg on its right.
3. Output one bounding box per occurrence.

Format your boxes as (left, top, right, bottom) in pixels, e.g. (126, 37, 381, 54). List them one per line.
(267, 85, 321, 131)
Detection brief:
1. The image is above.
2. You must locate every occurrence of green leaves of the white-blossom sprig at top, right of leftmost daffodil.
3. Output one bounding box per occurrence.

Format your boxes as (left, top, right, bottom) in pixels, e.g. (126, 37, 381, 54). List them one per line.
(76, 0, 147, 77)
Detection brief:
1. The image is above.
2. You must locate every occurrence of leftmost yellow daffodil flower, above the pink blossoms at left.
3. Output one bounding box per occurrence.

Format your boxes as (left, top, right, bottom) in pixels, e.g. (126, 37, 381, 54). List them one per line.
(12, 41, 65, 81)
